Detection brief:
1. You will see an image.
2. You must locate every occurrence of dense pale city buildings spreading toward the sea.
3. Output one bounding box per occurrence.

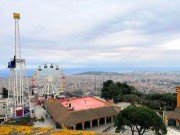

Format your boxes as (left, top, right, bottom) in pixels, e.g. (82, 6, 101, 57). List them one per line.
(0, 72, 180, 95)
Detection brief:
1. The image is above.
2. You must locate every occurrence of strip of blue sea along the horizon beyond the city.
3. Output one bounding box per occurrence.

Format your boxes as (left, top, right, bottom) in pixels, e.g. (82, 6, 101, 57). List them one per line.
(0, 67, 180, 78)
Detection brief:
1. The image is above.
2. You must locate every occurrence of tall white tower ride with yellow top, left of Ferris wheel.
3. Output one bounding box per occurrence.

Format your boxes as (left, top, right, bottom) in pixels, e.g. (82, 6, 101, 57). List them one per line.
(7, 13, 31, 118)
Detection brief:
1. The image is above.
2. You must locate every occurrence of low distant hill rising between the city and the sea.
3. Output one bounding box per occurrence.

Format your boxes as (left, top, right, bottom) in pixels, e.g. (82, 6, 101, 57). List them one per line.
(75, 71, 120, 75)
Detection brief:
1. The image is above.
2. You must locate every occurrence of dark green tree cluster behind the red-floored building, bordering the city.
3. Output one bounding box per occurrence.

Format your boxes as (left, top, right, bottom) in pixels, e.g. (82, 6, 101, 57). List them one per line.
(101, 80, 177, 111)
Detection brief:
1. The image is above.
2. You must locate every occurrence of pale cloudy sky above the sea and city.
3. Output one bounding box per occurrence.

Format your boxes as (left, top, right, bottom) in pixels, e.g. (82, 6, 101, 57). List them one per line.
(0, 0, 180, 73)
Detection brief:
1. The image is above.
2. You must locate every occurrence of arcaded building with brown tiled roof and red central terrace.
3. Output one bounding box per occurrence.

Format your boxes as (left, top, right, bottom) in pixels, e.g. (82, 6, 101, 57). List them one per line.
(45, 97, 120, 130)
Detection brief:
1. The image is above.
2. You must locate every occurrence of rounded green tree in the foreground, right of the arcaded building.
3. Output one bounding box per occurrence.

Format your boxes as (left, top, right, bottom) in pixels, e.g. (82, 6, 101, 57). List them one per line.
(114, 106, 167, 135)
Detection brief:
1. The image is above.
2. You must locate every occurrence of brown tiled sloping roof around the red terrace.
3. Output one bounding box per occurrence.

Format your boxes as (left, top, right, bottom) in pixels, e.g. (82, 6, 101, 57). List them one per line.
(45, 97, 119, 126)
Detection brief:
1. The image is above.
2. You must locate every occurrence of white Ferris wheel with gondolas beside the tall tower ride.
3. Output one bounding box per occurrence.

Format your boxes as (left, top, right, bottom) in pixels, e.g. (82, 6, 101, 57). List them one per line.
(31, 64, 66, 97)
